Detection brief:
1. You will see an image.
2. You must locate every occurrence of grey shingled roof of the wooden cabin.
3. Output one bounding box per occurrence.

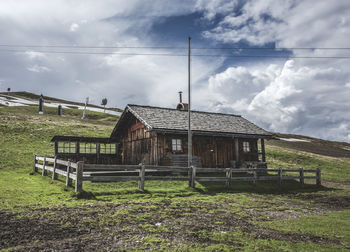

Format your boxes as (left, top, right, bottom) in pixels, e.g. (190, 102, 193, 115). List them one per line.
(112, 104, 271, 138)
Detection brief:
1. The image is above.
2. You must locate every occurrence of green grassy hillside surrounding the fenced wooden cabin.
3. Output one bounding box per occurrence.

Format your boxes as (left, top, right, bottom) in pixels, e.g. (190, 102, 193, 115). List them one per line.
(0, 106, 350, 251)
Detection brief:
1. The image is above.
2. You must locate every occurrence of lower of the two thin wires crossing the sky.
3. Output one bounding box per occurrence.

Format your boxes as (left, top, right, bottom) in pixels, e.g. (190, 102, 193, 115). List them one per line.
(0, 49, 350, 59)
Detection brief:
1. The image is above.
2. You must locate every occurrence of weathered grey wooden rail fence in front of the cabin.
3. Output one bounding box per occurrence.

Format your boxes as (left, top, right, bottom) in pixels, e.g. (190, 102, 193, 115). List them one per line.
(34, 155, 321, 192)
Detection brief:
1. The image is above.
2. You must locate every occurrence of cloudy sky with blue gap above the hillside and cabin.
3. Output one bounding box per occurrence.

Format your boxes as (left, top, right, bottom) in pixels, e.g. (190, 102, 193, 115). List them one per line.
(0, 0, 350, 142)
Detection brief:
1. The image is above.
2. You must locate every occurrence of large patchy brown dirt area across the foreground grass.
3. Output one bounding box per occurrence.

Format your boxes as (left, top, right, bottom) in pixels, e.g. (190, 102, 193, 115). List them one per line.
(0, 199, 339, 251)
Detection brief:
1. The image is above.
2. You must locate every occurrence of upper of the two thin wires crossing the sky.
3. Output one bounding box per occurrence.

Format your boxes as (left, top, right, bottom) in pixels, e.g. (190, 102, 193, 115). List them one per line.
(0, 44, 350, 50)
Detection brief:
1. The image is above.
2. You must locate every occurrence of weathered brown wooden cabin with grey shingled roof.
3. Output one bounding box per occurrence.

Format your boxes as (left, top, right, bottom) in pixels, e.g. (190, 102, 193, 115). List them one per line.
(110, 103, 272, 167)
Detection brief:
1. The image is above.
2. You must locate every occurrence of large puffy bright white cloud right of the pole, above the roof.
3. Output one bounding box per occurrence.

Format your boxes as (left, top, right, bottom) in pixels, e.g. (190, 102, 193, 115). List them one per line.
(205, 60, 350, 140)
